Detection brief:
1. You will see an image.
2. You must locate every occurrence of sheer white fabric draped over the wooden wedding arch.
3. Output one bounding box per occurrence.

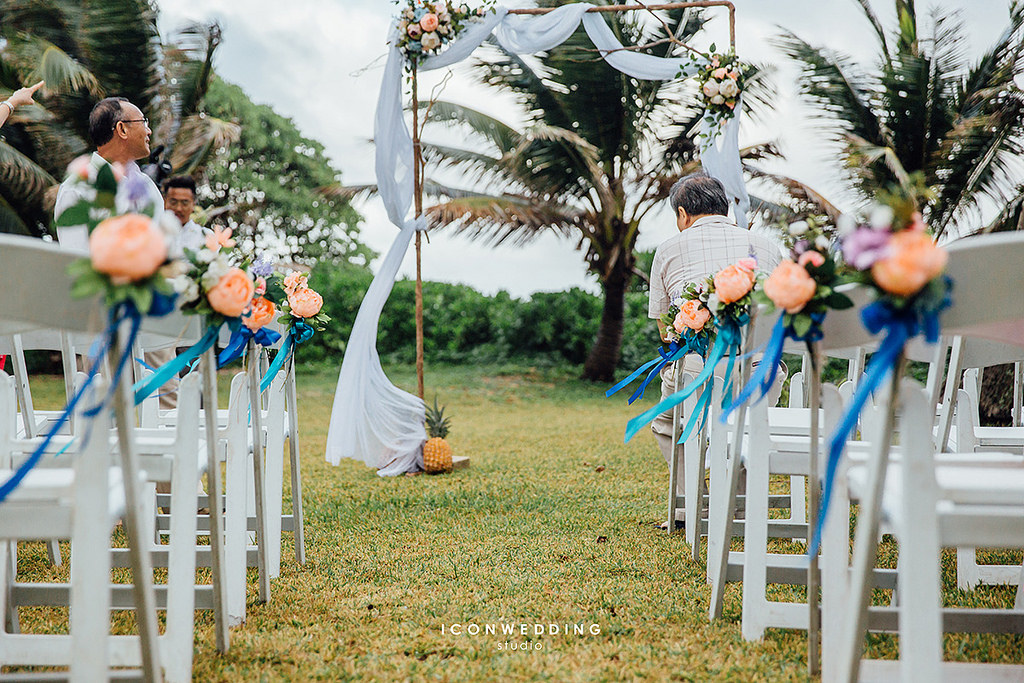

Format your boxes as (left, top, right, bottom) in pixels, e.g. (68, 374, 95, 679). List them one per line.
(327, 3, 750, 476)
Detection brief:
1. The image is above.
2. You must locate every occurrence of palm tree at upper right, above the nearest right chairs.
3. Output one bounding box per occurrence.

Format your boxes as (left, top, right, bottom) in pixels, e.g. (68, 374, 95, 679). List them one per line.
(779, 0, 1024, 236)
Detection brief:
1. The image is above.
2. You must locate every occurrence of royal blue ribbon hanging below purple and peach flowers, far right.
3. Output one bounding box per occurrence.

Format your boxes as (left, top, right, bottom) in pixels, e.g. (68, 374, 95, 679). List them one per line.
(808, 288, 952, 555)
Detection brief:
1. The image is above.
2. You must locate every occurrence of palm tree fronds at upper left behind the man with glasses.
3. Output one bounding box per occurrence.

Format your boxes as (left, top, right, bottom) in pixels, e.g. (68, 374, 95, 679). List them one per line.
(0, 0, 238, 237)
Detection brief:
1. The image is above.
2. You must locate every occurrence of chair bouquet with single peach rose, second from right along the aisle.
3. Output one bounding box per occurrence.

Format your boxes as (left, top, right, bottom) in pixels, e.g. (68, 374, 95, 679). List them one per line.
(756, 216, 853, 339)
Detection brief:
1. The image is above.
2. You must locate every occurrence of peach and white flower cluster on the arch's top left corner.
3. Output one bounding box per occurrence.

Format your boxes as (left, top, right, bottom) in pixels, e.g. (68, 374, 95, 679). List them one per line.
(396, 0, 494, 65)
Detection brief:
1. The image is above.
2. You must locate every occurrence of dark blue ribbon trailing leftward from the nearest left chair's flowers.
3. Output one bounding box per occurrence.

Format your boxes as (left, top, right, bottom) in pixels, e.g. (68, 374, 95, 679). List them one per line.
(0, 301, 142, 503)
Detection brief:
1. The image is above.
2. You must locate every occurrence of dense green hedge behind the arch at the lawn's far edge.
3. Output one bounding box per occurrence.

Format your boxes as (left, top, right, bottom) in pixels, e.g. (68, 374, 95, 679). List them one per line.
(302, 264, 657, 369)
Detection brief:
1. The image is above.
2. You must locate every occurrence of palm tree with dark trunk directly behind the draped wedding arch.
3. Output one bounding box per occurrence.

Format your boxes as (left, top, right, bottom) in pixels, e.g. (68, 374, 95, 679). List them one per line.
(415, 0, 771, 382)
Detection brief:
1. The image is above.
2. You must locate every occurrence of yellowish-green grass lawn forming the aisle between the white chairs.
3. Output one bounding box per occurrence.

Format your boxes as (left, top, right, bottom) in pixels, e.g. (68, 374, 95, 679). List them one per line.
(9, 368, 1024, 681)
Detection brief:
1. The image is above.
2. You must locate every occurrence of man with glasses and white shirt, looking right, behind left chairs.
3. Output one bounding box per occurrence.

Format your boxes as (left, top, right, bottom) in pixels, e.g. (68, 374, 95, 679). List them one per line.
(53, 97, 178, 409)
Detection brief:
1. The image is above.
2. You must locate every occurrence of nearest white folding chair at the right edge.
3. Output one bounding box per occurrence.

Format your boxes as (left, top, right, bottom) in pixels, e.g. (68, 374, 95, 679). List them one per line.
(828, 232, 1024, 681)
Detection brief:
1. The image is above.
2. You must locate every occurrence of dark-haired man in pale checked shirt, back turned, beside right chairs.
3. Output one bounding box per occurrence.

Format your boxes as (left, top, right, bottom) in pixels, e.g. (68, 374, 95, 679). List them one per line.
(647, 173, 785, 527)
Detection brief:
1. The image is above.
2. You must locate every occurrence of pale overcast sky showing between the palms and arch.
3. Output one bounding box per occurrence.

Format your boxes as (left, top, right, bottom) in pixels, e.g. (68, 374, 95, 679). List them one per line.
(160, 0, 1009, 297)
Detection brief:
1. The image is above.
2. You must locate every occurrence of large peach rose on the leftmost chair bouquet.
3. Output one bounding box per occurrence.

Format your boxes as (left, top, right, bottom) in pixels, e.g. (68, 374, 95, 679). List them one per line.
(89, 213, 167, 285)
